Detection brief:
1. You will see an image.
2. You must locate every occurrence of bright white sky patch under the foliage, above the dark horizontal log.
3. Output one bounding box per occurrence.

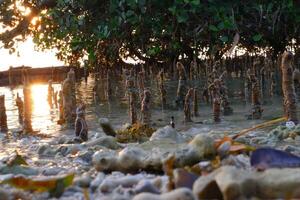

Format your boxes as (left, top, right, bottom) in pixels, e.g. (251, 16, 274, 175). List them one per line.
(0, 38, 64, 71)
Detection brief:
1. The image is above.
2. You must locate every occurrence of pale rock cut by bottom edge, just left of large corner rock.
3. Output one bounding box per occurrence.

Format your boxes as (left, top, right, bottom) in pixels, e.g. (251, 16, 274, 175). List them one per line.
(133, 188, 196, 200)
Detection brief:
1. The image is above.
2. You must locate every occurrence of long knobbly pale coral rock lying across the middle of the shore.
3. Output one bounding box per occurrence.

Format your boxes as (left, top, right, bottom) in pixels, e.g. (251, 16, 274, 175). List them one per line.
(93, 132, 216, 172)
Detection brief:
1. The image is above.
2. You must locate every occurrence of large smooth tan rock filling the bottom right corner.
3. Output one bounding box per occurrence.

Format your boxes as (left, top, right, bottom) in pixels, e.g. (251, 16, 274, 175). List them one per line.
(193, 166, 300, 200)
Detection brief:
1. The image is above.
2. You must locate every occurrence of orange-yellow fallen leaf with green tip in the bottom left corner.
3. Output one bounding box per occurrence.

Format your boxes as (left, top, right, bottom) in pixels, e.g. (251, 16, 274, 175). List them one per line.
(0, 174, 74, 197)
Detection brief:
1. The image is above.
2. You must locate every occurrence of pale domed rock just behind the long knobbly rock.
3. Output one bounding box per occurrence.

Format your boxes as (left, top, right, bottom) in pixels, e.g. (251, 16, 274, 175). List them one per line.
(149, 126, 184, 142)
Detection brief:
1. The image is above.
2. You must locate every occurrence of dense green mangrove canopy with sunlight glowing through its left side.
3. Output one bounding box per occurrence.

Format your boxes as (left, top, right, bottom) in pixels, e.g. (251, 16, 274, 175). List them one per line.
(0, 0, 300, 65)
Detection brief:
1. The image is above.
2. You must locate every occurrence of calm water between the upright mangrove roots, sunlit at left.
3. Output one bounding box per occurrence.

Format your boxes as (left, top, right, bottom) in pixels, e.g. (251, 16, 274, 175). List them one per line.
(0, 77, 288, 134)
